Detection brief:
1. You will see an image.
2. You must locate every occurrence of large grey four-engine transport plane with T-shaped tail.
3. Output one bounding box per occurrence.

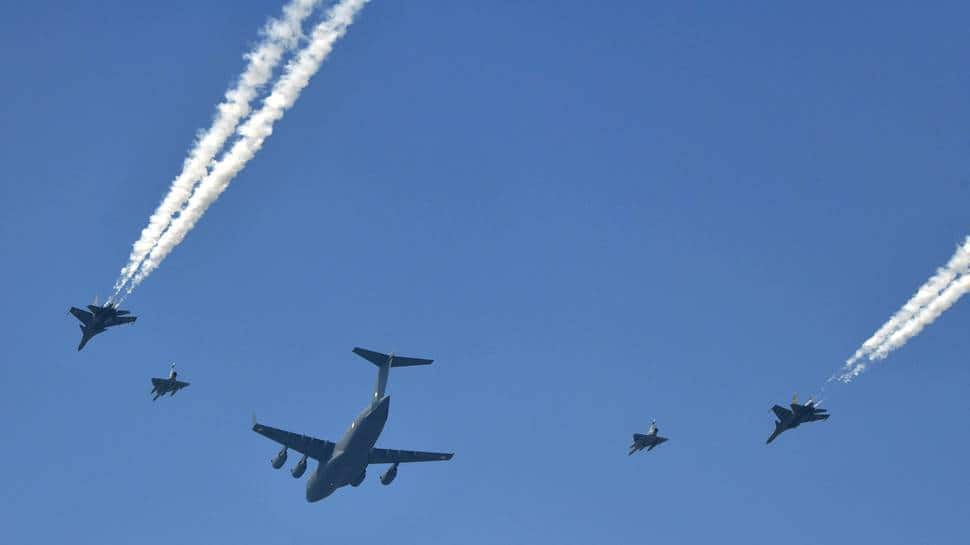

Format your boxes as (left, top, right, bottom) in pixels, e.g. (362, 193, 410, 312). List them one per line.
(253, 348, 454, 502)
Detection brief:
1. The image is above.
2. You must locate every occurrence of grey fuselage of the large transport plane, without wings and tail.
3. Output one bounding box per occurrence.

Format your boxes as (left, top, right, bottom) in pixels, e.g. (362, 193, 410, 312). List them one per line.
(306, 396, 391, 502)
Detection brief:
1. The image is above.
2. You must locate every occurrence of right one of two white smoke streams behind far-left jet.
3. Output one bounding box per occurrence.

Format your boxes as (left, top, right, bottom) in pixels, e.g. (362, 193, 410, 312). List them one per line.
(127, 0, 368, 293)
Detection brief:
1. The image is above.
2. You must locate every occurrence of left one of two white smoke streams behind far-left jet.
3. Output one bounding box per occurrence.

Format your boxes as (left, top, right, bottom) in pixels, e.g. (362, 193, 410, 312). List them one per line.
(109, 0, 320, 300)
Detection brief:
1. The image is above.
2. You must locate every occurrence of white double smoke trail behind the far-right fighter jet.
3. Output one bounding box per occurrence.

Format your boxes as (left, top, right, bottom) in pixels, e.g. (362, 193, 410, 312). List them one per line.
(833, 237, 970, 383)
